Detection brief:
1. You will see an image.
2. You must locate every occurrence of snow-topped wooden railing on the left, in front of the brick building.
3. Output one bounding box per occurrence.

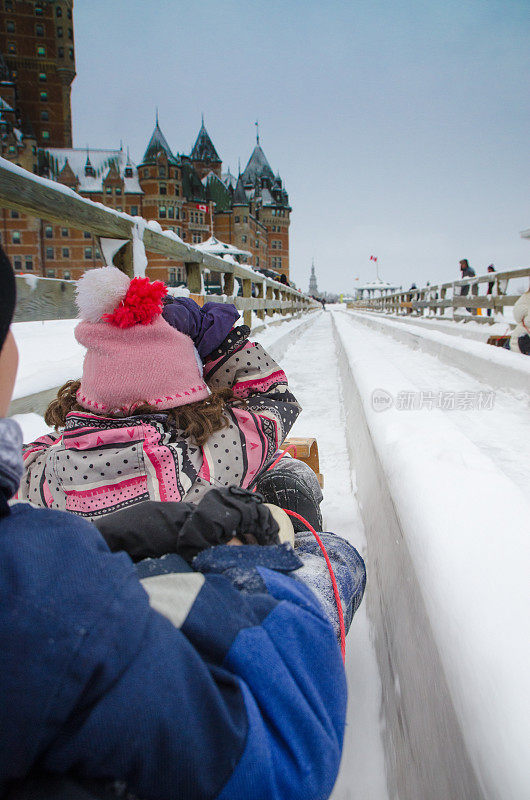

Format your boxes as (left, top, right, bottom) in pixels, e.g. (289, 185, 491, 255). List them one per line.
(0, 158, 319, 325)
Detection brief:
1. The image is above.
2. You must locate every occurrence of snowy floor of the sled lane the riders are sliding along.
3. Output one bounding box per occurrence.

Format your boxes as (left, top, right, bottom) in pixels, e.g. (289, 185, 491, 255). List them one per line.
(271, 313, 388, 800)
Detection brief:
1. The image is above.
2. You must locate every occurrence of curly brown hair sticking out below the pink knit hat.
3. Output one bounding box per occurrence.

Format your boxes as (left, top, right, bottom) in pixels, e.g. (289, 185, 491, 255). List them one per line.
(44, 380, 246, 447)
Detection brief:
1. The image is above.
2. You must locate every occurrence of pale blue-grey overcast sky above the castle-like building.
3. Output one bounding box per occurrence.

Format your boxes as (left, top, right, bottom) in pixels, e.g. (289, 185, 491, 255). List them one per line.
(72, 0, 530, 292)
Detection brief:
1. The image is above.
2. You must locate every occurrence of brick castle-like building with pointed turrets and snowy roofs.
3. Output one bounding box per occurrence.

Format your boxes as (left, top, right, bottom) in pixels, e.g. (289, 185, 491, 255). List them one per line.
(0, 0, 291, 284)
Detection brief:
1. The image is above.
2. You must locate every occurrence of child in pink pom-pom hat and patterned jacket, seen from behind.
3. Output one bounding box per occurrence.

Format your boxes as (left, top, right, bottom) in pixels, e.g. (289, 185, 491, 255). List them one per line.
(18, 267, 300, 519)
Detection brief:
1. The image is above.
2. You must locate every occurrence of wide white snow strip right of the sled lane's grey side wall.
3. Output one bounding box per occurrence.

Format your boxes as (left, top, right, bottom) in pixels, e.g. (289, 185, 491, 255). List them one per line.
(334, 311, 530, 800)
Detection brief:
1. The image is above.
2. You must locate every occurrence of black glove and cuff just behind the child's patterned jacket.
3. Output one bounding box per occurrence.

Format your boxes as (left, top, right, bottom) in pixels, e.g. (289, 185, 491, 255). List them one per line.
(94, 486, 279, 561)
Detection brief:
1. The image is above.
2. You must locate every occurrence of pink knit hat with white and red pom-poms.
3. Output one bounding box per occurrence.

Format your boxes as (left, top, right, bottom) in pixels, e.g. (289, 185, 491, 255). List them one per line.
(75, 267, 210, 413)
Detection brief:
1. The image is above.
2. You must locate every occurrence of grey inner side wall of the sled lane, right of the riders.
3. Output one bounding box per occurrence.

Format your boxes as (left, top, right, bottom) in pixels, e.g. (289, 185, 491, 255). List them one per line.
(333, 317, 483, 800)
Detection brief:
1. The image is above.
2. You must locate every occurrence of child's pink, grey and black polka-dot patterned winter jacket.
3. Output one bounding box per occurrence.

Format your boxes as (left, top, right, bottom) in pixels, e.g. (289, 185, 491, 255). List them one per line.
(18, 326, 300, 519)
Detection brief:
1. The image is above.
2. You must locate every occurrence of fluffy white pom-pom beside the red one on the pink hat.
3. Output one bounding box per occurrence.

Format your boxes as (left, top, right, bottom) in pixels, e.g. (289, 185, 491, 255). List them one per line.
(76, 267, 131, 322)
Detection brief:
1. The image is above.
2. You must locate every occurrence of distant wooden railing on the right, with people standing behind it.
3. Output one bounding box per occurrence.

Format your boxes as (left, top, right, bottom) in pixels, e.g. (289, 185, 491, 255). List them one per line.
(350, 267, 530, 323)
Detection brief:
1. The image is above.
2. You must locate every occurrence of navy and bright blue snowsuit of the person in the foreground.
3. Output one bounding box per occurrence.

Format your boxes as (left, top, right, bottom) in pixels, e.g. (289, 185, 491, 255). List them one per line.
(0, 507, 346, 800)
